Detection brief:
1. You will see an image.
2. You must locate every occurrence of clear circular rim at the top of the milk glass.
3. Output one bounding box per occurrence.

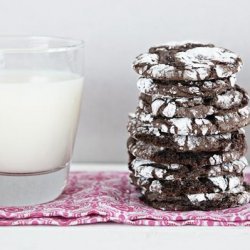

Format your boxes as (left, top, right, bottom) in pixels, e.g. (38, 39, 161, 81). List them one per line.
(0, 35, 84, 53)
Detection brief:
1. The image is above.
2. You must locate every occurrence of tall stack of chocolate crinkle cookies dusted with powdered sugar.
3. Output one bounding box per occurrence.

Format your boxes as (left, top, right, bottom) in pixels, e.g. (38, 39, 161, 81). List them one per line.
(127, 42, 250, 211)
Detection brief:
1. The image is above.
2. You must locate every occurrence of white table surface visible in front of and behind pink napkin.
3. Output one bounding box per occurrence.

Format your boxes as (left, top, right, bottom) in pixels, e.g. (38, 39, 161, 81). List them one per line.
(0, 164, 250, 250)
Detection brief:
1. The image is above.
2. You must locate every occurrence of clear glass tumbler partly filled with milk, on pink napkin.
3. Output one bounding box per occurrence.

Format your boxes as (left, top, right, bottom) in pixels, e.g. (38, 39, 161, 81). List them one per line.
(0, 37, 84, 206)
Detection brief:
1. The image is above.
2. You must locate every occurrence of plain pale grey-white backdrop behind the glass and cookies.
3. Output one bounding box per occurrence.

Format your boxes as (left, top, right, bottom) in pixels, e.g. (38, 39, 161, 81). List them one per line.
(0, 0, 250, 162)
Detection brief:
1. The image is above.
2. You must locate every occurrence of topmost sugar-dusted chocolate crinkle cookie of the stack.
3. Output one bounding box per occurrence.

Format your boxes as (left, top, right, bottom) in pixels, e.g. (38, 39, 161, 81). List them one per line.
(133, 42, 242, 81)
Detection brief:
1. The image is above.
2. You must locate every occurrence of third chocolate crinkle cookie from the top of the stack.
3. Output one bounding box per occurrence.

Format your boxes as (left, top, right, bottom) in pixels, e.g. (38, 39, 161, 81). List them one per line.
(139, 86, 249, 122)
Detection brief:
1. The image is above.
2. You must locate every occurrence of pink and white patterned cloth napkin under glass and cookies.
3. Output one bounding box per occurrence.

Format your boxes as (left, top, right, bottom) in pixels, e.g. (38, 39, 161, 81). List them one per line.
(0, 172, 250, 226)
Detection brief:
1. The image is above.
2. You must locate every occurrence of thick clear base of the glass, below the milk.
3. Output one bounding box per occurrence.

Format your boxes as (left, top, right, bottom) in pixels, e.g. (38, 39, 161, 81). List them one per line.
(0, 164, 69, 207)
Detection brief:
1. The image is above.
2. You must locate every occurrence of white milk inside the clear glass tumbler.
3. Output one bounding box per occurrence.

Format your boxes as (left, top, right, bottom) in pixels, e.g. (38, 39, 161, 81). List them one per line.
(0, 71, 83, 173)
